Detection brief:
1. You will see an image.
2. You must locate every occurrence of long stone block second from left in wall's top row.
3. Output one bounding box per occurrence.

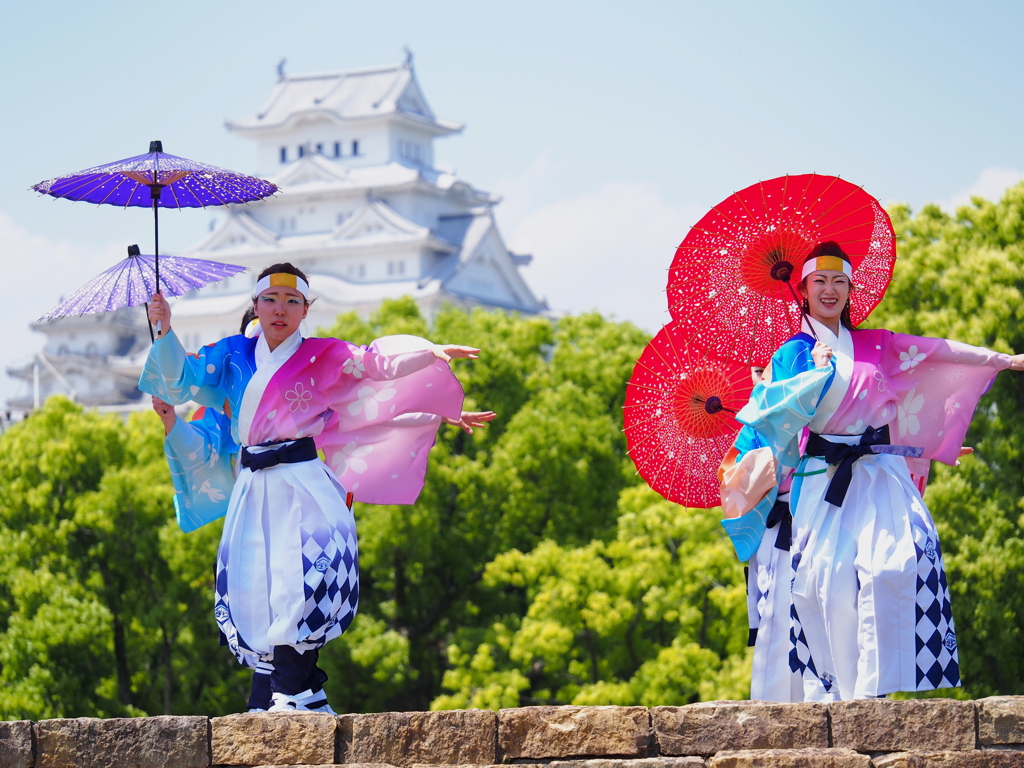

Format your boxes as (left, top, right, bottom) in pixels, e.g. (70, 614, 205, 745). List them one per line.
(36, 716, 210, 768)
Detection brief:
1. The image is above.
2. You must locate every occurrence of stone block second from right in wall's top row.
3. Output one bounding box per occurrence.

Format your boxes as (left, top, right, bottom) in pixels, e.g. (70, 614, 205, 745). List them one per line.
(828, 698, 976, 752)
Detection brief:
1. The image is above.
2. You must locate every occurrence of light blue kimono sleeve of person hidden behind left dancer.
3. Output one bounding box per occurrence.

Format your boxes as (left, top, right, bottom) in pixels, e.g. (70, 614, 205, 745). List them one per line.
(164, 408, 239, 534)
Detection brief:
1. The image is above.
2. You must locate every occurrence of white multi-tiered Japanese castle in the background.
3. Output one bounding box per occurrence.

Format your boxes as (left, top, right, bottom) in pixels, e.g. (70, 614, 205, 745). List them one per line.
(7, 55, 548, 411)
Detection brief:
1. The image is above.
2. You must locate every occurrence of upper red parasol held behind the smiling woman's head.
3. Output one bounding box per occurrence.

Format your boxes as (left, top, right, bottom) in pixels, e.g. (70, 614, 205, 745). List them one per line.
(668, 173, 896, 366)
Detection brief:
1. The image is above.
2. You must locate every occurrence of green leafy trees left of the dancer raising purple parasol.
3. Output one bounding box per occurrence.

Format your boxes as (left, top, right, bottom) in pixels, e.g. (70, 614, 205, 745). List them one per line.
(0, 397, 245, 719)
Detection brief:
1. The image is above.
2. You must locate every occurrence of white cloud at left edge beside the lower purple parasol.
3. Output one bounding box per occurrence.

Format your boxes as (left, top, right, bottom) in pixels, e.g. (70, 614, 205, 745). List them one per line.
(0, 212, 123, 406)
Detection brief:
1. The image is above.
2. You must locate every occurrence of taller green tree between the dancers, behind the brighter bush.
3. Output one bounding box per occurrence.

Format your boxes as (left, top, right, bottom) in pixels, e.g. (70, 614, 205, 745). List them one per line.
(322, 299, 646, 710)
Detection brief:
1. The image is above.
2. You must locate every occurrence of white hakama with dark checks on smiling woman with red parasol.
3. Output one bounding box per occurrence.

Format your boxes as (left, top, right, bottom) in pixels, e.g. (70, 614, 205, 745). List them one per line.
(793, 435, 961, 701)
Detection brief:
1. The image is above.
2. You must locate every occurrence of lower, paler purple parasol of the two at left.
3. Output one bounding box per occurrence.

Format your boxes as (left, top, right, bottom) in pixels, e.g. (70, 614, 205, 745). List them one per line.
(39, 246, 247, 342)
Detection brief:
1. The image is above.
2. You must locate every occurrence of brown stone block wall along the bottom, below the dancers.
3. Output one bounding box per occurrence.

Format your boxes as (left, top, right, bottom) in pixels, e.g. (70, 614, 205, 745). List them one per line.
(0, 696, 1024, 768)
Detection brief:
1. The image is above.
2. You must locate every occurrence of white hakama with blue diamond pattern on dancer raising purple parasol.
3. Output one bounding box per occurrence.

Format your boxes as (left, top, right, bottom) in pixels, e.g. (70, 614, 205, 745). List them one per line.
(215, 447, 359, 668)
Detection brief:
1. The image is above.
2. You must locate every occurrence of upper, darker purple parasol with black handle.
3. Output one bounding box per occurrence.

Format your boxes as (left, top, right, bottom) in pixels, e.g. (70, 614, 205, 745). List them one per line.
(32, 141, 278, 289)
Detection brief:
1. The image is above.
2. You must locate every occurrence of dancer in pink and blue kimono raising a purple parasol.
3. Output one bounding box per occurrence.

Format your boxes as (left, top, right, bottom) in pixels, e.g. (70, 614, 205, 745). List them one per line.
(139, 263, 479, 711)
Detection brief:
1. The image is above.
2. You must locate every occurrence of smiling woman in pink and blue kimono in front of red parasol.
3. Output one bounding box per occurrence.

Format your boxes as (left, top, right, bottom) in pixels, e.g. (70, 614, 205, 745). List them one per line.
(737, 242, 1024, 700)
